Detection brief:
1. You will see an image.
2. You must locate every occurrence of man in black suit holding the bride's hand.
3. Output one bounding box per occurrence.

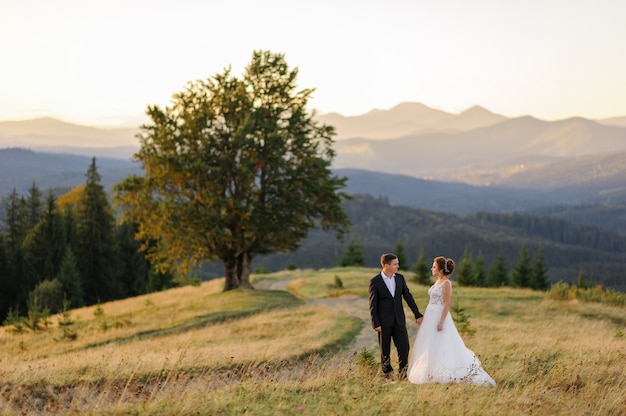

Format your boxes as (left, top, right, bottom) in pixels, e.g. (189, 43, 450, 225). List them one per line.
(369, 254, 423, 379)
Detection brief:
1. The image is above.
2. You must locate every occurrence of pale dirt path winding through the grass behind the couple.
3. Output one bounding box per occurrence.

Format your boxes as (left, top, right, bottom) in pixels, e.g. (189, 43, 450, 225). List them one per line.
(254, 280, 417, 352)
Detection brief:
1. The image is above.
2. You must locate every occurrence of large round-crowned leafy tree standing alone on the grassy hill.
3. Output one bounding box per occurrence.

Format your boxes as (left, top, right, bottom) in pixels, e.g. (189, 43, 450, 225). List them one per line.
(115, 51, 349, 290)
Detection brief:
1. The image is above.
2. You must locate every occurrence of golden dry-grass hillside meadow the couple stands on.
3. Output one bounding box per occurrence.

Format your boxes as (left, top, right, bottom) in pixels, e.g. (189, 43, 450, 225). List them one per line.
(0, 268, 626, 415)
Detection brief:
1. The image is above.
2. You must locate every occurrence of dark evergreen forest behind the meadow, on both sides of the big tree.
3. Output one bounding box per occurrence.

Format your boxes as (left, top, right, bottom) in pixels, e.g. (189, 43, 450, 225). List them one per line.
(0, 164, 626, 322)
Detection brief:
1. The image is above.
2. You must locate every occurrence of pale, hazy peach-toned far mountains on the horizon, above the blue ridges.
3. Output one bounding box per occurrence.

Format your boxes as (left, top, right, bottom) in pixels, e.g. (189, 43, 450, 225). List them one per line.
(0, 103, 626, 188)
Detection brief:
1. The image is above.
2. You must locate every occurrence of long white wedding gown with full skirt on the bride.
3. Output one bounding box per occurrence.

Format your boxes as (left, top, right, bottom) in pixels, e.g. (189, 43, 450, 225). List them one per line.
(407, 280, 496, 386)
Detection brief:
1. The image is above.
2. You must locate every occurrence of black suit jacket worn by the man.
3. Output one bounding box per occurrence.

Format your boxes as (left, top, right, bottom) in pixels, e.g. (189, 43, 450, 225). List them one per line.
(369, 273, 423, 328)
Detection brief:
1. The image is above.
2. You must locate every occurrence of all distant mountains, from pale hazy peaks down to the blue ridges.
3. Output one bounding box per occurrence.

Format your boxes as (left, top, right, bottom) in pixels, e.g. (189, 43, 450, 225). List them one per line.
(0, 103, 626, 214)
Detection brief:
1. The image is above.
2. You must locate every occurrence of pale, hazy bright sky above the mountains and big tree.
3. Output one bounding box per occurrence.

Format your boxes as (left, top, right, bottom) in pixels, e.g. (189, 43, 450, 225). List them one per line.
(0, 0, 626, 125)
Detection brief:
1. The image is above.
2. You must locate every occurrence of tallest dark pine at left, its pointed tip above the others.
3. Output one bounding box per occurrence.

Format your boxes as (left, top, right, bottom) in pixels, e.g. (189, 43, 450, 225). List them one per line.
(76, 157, 120, 305)
